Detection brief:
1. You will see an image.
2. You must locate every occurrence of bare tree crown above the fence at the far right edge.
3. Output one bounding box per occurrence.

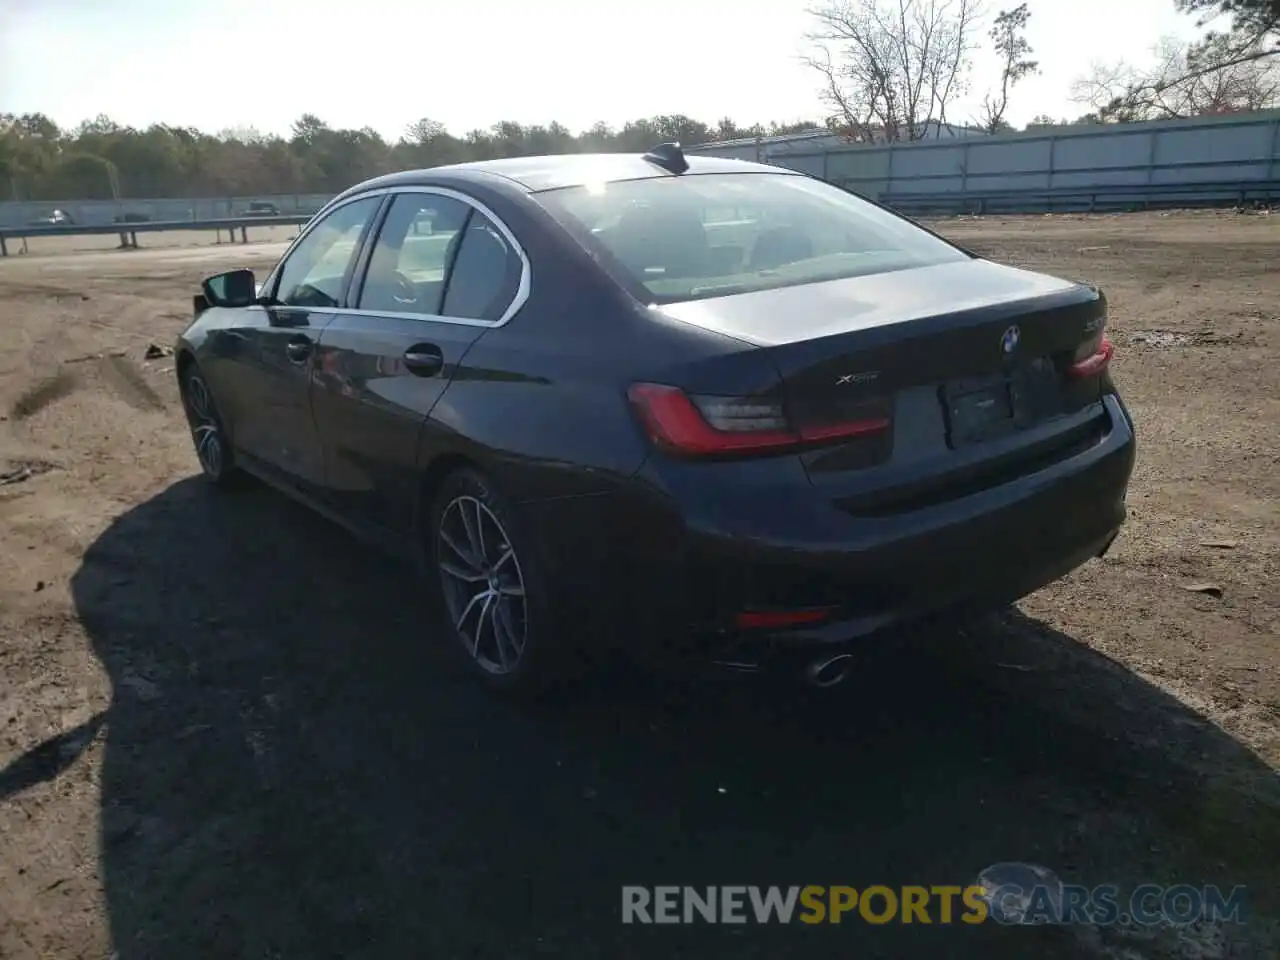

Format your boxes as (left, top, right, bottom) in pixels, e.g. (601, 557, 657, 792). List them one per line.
(1071, 35, 1280, 123)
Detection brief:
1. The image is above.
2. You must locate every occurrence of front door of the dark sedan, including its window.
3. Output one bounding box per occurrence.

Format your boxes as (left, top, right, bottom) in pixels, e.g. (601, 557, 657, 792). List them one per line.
(228, 196, 383, 485)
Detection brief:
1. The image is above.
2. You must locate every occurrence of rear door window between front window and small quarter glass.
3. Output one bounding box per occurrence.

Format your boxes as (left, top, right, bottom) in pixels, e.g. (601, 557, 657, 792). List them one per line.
(356, 193, 471, 314)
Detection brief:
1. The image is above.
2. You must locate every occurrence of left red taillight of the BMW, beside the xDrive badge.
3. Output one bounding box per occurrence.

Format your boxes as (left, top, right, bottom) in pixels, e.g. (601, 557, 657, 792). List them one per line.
(627, 383, 890, 457)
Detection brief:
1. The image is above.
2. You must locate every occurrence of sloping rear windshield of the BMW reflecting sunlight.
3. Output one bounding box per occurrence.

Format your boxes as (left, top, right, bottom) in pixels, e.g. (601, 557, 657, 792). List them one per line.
(536, 173, 968, 303)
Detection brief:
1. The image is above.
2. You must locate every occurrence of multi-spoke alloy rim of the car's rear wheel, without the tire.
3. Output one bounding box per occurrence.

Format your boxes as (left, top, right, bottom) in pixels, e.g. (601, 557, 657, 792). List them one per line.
(436, 495, 527, 675)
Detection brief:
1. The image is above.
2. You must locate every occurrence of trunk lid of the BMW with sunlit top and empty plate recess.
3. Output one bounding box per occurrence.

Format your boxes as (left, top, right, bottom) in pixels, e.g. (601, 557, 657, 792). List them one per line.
(660, 260, 1106, 503)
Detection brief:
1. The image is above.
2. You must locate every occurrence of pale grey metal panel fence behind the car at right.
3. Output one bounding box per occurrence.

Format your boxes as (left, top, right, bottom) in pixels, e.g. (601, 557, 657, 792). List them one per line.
(698, 110, 1280, 210)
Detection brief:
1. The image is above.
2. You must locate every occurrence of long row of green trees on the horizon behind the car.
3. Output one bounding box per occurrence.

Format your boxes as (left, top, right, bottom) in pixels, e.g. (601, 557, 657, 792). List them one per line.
(0, 114, 822, 201)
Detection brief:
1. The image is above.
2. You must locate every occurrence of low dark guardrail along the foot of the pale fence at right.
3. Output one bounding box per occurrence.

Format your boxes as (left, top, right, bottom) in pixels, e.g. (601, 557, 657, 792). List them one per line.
(880, 180, 1280, 214)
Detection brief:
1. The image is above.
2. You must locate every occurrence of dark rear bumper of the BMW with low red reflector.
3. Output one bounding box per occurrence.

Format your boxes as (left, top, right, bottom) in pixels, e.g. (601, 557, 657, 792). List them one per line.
(524, 394, 1135, 649)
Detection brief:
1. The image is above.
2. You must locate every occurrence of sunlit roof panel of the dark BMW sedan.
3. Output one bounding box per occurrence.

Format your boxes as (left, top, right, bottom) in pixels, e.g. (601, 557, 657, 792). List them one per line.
(348, 154, 803, 193)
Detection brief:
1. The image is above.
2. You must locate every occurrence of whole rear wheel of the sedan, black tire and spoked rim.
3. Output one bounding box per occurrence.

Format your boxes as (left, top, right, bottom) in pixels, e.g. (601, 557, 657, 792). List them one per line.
(424, 468, 564, 695)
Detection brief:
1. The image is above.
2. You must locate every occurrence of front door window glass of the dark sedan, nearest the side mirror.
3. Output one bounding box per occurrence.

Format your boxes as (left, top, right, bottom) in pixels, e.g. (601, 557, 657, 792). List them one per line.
(275, 197, 381, 307)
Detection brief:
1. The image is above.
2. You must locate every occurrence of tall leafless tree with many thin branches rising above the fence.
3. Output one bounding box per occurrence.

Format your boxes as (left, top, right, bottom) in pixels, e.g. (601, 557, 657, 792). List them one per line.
(805, 0, 980, 142)
